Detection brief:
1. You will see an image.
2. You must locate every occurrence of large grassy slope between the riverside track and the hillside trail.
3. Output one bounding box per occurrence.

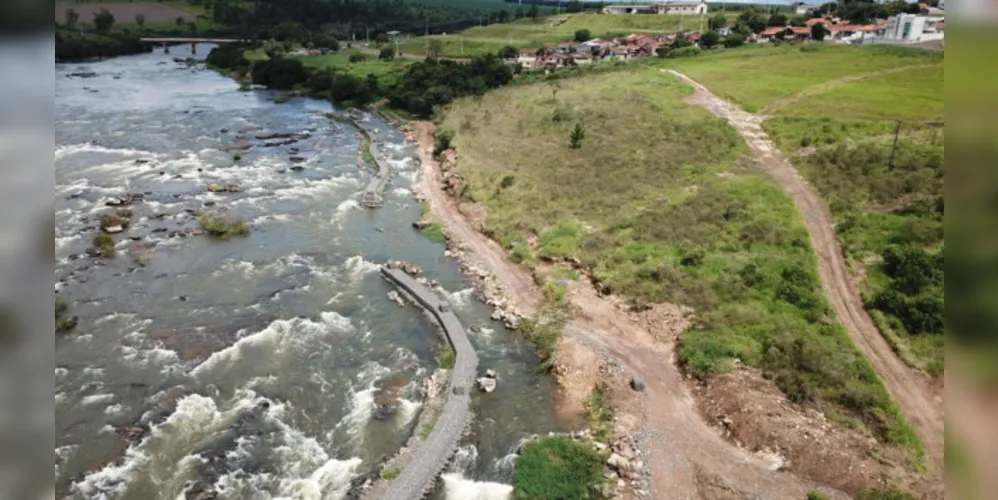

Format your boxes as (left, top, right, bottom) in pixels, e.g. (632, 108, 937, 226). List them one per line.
(441, 66, 919, 456)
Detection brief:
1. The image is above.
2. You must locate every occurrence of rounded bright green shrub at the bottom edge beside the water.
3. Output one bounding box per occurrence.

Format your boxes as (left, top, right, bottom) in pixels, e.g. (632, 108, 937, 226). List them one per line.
(513, 436, 603, 500)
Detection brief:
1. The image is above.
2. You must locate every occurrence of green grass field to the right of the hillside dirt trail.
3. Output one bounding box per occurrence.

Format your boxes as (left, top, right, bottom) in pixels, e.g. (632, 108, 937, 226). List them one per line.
(700, 46, 945, 374)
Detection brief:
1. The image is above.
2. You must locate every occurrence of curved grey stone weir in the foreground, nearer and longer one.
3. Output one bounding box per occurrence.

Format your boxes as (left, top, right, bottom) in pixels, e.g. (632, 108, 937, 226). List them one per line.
(362, 266, 478, 500)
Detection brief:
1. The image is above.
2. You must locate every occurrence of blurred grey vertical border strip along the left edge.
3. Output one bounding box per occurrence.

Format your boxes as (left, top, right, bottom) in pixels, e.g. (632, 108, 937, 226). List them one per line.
(0, 0, 55, 500)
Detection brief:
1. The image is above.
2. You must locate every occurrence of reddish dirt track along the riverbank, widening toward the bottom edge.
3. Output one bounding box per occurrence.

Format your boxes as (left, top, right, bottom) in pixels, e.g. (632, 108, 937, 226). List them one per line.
(412, 122, 849, 500)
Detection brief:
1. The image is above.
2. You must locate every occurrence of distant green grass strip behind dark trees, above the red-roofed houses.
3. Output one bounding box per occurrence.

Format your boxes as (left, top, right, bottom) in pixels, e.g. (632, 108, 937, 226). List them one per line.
(402, 13, 728, 57)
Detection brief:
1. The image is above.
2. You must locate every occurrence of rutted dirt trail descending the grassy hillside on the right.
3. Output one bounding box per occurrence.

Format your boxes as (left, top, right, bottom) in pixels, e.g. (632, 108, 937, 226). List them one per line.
(663, 70, 943, 473)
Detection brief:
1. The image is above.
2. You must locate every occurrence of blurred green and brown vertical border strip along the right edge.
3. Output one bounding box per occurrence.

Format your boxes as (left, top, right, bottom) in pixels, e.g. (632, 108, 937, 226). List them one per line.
(946, 10, 998, 500)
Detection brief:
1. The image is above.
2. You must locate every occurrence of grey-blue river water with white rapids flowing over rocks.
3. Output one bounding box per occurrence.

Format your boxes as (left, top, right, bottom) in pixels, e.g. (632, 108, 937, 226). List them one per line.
(55, 46, 562, 500)
